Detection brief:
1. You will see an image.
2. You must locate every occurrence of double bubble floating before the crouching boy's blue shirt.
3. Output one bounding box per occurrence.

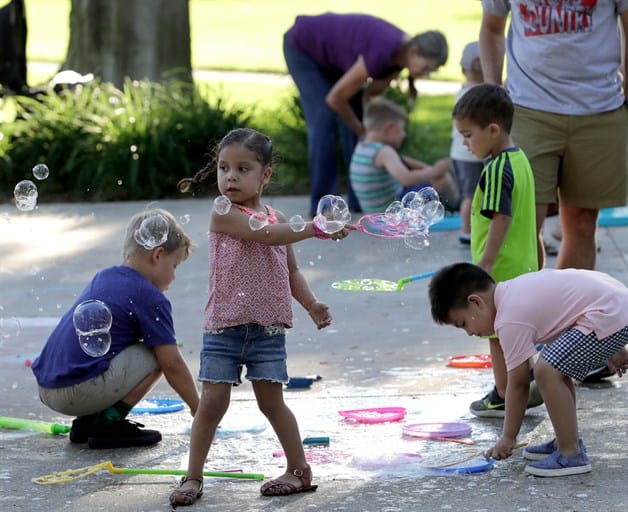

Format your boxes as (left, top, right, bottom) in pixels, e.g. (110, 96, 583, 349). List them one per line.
(72, 299, 112, 357)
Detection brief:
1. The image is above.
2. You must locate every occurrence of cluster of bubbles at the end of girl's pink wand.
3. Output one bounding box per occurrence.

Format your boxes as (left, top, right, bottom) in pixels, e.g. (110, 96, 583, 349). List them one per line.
(384, 187, 445, 250)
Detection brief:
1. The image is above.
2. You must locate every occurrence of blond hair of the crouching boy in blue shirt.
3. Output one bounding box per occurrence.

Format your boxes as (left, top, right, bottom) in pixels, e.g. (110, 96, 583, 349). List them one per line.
(122, 208, 195, 259)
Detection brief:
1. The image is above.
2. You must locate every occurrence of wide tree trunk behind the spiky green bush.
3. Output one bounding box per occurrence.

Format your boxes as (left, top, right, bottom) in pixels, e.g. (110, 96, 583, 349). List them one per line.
(62, 0, 192, 87)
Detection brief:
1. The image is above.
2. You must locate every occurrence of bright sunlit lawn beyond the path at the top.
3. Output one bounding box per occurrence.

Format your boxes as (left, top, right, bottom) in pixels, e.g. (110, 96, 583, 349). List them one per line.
(25, 0, 482, 83)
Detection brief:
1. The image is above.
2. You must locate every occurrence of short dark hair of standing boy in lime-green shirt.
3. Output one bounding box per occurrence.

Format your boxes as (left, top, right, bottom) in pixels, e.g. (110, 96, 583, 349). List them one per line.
(451, 84, 514, 133)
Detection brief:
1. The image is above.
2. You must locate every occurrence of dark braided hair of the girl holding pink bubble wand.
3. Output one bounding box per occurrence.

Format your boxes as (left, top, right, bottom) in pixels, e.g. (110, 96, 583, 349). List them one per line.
(177, 128, 273, 192)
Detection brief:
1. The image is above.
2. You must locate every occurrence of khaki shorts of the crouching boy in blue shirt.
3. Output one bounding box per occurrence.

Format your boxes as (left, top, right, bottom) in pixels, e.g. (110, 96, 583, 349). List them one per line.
(39, 344, 159, 416)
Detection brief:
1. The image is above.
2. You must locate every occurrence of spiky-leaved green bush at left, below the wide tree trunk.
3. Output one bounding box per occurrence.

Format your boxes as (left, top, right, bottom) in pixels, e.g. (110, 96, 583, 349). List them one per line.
(0, 81, 250, 201)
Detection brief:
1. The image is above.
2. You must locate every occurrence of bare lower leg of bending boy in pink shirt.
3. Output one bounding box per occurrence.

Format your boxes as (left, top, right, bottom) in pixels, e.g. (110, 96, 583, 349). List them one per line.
(534, 357, 580, 456)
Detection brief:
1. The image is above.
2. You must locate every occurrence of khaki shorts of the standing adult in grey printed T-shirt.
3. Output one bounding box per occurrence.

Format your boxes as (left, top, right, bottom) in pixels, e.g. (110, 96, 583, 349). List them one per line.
(512, 105, 628, 209)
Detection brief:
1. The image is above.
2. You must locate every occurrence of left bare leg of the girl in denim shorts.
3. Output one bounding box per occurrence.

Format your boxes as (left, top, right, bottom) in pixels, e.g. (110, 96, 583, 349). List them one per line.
(180, 382, 232, 490)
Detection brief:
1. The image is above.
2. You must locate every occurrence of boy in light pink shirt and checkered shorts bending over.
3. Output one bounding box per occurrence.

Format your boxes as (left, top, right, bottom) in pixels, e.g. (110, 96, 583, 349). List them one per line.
(429, 263, 628, 477)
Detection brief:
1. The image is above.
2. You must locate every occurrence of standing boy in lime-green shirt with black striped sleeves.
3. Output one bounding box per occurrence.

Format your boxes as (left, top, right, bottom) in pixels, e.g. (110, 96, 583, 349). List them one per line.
(452, 84, 542, 417)
